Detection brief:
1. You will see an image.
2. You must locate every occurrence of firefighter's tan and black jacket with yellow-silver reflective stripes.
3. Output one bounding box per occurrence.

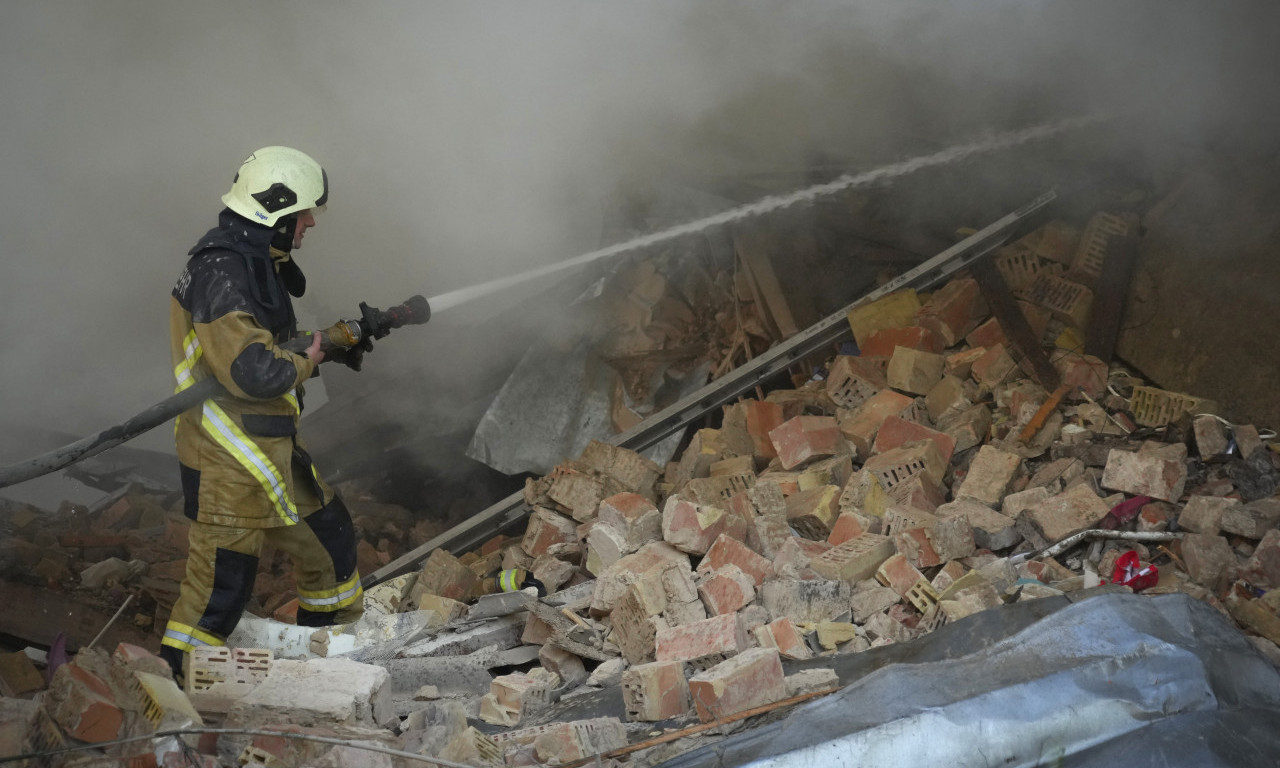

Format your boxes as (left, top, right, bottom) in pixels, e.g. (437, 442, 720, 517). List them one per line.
(169, 210, 333, 527)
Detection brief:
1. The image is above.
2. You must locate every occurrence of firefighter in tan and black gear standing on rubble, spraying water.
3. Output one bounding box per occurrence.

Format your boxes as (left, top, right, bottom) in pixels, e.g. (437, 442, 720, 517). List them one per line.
(160, 147, 364, 676)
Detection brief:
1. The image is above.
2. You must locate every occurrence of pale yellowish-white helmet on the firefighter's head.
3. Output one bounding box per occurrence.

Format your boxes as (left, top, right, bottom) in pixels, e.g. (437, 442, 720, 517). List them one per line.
(223, 147, 329, 227)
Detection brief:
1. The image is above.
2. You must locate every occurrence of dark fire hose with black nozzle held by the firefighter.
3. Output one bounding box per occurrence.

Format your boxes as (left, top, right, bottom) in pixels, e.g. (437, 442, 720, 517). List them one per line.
(0, 296, 431, 488)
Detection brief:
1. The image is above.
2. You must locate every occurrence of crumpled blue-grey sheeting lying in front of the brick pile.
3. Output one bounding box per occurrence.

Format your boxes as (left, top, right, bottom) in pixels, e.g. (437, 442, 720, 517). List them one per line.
(663, 594, 1280, 768)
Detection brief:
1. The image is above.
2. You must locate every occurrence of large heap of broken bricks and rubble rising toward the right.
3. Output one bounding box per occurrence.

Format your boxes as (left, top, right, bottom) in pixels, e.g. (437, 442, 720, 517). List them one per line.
(0, 212, 1280, 765)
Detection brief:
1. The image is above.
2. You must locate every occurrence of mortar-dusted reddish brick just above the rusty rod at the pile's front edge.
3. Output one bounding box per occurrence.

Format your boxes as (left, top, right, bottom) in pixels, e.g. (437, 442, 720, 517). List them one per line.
(689, 648, 787, 722)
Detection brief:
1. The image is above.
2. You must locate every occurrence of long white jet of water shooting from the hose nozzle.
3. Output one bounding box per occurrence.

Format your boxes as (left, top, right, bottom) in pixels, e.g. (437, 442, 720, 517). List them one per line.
(429, 115, 1106, 314)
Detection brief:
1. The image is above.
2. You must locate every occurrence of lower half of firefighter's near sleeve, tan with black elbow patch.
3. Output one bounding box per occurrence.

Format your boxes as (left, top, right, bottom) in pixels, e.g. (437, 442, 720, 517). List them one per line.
(195, 310, 316, 401)
